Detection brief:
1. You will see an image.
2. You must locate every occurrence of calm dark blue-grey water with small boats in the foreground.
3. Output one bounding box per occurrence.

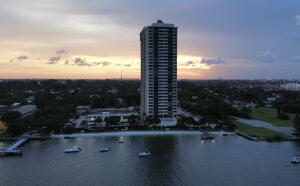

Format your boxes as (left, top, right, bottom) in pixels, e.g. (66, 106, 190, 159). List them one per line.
(0, 132, 300, 186)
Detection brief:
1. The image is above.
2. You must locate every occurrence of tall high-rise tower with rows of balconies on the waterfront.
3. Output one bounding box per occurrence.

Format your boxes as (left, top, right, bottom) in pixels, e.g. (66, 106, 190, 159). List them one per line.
(140, 20, 177, 125)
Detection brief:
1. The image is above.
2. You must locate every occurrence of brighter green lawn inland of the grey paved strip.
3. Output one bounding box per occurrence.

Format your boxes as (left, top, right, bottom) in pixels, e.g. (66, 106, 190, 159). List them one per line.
(250, 107, 294, 127)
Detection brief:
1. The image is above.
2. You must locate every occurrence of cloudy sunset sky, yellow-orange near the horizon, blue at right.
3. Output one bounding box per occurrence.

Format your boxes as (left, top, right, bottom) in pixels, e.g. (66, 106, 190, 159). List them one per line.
(0, 0, 300, 79)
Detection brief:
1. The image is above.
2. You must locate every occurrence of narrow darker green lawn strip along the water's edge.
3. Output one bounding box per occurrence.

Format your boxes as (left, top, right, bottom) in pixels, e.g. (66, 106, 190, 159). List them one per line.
(233, 120, 287, 138)
